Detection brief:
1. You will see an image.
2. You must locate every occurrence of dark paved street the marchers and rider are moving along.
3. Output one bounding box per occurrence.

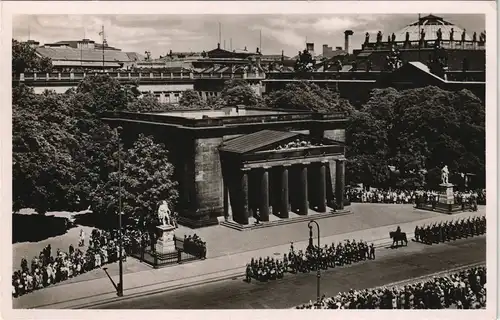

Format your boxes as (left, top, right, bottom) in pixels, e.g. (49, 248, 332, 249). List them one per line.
(97, 236, 486, 309)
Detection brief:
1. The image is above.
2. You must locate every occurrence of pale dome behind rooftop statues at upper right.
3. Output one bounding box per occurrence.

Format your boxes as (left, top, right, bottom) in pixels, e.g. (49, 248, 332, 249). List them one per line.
(390, 15, 472, 41)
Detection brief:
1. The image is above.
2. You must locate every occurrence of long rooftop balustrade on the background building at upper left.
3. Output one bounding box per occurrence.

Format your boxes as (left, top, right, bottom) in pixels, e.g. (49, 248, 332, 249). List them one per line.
(12, 72, 266, 82)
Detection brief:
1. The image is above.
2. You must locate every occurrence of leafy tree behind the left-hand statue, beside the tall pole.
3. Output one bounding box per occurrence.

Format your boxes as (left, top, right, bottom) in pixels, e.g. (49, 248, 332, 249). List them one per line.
(92, 134, 178, 227)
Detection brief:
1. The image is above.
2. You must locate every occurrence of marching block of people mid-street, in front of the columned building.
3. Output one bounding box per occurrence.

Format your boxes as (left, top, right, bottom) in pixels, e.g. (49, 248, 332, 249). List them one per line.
(246, 240, 375, 282)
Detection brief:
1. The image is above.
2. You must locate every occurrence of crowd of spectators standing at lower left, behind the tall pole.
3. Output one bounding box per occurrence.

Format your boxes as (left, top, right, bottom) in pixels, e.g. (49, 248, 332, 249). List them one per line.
(12, 229, 126, 297)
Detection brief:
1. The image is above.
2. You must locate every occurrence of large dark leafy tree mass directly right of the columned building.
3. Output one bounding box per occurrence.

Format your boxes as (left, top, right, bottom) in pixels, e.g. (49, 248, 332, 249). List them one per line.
(346, 87, 485, 188)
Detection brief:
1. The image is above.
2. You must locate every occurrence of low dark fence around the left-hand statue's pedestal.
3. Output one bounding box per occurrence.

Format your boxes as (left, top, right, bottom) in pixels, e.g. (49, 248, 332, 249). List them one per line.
(129, 239, 206, 268)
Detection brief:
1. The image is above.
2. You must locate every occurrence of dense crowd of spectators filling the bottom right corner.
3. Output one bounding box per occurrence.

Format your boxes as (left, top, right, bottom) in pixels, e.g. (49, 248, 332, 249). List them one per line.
(296, 267, 486, 309)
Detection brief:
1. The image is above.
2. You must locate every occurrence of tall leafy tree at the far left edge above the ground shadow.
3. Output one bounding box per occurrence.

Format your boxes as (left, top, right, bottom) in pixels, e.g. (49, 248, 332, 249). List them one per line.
(12, 85, 77, 214)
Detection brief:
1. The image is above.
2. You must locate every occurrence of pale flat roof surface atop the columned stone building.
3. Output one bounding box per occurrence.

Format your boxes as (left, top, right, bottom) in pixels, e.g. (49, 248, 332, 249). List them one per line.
(148, 107, 300, 119)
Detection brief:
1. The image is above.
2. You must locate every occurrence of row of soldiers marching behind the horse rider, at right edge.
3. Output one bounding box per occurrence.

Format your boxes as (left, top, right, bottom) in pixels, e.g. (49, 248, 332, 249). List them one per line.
(415, 216, 486, 244)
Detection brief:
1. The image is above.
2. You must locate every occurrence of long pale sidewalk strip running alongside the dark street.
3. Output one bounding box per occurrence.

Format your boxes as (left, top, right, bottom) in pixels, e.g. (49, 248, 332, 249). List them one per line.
(13, 210, 485, 309)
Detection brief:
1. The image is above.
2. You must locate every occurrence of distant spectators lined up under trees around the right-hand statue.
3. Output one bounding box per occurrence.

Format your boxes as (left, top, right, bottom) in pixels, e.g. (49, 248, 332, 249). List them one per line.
(346, 189, 486, 209)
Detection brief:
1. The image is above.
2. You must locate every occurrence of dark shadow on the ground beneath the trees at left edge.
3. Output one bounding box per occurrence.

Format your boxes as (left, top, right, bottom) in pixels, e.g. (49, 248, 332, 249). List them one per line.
(12, 214, 71, 244)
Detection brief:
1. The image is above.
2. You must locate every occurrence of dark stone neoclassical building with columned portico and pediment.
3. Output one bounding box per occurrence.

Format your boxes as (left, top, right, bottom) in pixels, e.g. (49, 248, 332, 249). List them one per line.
(104, 108, 346, 227)
